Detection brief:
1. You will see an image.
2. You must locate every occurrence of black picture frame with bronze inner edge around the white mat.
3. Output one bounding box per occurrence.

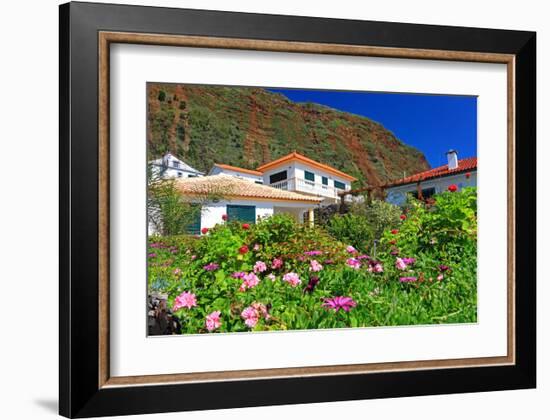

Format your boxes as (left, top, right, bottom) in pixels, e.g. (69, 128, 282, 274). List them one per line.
(59, 2, 536, 418)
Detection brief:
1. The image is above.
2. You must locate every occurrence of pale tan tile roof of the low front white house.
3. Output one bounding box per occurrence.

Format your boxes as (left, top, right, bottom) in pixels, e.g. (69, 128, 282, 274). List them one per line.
(176, 174, 323, 204)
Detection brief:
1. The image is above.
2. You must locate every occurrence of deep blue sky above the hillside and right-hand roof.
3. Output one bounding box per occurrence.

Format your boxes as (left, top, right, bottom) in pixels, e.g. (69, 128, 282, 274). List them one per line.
(269, 89, 477, 167)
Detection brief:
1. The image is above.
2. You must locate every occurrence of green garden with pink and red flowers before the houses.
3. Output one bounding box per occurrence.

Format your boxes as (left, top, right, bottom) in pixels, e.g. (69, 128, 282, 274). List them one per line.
(147, 186, 477, 334)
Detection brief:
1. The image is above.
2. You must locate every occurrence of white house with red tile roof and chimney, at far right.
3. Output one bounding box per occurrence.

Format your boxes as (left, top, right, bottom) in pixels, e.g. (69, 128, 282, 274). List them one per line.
(384, 150, 477, 206)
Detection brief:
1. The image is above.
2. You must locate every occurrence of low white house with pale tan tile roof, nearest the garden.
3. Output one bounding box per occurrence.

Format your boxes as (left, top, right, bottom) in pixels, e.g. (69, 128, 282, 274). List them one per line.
(177, 173, 323, 234)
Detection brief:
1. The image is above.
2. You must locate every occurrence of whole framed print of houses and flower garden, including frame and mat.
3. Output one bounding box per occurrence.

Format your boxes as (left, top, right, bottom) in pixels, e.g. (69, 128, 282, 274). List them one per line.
(60, 3, 535, 417)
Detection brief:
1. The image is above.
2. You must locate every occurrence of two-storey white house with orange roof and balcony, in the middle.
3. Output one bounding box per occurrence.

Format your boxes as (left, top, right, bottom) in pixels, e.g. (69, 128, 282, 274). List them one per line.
(256, 152, 356, 205)
